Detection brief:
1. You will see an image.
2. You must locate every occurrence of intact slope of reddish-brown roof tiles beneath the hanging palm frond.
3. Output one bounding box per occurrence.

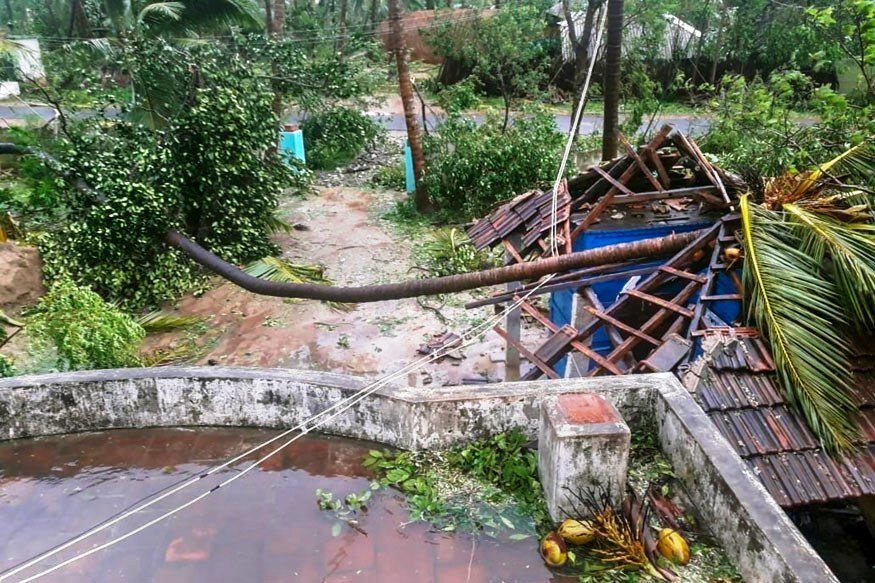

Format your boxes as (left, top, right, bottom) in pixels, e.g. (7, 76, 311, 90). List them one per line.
(696, 328, 875, 507)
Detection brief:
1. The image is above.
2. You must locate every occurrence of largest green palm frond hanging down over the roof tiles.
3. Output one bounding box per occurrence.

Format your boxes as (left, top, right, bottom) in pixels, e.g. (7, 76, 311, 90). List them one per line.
(741, 195, 859, 452)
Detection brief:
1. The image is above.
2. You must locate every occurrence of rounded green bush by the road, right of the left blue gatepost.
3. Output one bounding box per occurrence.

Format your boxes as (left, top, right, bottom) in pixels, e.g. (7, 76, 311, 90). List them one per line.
(301, 107, 382, 170)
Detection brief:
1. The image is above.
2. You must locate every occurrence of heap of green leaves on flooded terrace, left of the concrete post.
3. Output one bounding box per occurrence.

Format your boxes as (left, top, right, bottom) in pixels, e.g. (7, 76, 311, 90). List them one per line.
(364, 430, 549, 540)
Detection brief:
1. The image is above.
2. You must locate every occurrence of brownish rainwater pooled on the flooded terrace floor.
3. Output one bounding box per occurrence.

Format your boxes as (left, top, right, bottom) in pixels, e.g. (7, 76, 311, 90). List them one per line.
(0, 429, 572, 583)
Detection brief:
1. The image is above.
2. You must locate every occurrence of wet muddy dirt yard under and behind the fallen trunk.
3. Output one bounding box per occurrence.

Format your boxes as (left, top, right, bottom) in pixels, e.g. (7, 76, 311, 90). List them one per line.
(140, 188, 544, 386)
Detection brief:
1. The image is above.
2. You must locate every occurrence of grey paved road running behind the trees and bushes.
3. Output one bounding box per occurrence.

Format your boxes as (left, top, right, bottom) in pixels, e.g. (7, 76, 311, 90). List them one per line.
(0, 105, 709, 134)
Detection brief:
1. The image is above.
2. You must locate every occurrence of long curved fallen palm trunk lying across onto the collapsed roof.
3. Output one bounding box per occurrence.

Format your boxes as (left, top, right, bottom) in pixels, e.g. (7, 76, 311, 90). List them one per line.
(165, 228, 707, 304)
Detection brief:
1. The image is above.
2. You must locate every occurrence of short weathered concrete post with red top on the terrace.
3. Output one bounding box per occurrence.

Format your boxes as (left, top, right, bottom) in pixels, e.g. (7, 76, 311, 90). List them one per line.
(538, 393, 632, 522)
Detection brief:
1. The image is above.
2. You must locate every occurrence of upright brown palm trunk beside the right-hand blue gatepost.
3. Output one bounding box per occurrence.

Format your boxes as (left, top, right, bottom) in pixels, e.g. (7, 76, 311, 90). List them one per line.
(389, 0, 434, 213)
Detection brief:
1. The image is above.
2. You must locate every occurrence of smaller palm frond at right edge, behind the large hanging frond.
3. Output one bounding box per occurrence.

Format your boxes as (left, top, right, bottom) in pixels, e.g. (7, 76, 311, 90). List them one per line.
(784, 204, 875, 331)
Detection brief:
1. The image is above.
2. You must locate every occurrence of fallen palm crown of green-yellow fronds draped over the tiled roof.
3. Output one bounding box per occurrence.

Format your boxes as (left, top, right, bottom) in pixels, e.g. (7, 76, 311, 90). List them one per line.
(741, 143, 875, 452)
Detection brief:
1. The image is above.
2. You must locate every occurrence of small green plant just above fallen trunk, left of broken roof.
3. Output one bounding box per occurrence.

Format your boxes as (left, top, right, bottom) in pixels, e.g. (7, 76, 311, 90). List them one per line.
(414, 227, 495, 277)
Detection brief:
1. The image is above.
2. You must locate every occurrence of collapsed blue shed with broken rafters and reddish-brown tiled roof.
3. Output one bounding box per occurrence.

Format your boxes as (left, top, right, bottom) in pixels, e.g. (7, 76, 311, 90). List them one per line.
(468, 127, 875, 520)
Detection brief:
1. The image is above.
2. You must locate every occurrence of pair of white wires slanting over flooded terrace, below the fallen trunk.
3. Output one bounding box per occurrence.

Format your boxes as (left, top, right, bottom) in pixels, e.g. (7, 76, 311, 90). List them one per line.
(0, 274, 555, 583)
